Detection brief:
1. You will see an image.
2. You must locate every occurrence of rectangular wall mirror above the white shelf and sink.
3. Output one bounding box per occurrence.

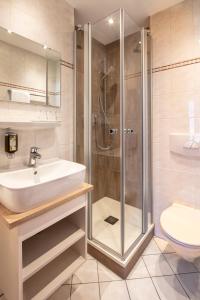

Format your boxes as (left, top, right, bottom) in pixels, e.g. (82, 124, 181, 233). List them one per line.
(0, 28, 61, 107)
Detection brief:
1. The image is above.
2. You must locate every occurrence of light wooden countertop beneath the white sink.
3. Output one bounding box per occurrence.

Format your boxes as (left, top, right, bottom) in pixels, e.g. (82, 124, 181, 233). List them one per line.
(0, 183, 93, 228)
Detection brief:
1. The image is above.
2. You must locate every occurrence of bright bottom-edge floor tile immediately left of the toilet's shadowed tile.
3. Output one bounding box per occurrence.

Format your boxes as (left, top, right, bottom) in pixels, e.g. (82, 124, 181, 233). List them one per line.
(127, 278, 159, 300)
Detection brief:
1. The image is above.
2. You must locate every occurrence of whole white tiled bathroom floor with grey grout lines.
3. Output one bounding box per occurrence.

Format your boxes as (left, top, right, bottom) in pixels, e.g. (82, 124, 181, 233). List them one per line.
(0, 238, 200, 300)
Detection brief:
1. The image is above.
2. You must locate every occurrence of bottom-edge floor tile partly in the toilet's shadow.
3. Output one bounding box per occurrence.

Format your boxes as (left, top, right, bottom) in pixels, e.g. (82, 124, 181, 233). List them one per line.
(152, 275, 188, 300)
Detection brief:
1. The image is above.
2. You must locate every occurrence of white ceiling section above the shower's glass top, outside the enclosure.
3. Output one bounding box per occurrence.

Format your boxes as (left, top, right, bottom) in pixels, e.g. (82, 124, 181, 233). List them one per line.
(66, 0, 182, 26)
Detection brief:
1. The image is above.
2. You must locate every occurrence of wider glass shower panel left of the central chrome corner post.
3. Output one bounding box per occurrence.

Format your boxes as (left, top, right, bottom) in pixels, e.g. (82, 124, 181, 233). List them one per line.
(91, 11, 121, 254)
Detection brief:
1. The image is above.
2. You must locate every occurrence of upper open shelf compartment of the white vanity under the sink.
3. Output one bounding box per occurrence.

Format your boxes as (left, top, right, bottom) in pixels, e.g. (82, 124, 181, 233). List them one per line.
(22, 219, 85, 281)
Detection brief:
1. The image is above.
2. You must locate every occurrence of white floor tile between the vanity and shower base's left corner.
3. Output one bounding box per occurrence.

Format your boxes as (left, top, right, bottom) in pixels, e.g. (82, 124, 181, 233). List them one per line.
(72, 259, 98, 284)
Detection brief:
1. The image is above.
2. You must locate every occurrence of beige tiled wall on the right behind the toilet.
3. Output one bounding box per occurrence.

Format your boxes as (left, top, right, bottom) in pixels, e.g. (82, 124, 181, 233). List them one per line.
(151, 0, 200, 234)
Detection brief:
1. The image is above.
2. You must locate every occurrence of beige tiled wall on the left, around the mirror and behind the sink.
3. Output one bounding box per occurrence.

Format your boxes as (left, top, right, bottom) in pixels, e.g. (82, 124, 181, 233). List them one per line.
(0, 0, 74, 170)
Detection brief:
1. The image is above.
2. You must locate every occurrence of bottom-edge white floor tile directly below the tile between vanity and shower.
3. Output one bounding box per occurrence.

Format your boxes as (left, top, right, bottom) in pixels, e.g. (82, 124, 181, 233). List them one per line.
(71, 283, 100, 300)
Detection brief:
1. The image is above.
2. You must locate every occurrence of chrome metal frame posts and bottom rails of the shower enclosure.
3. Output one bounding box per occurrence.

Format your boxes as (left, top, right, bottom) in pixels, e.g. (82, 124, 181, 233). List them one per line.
(84, 9, 153, 261)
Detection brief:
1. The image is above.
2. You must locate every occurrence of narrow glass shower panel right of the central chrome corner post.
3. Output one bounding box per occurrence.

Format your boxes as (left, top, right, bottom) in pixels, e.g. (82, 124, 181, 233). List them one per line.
(123, 13, 143, 252)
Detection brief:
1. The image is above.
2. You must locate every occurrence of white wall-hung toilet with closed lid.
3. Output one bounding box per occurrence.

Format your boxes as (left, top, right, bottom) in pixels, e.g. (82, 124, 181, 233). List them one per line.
(160, 203, 200, 262)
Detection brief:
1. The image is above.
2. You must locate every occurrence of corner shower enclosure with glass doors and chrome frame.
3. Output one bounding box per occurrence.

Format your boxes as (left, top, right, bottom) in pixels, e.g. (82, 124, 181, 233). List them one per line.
(75, 9, 152, 260)
